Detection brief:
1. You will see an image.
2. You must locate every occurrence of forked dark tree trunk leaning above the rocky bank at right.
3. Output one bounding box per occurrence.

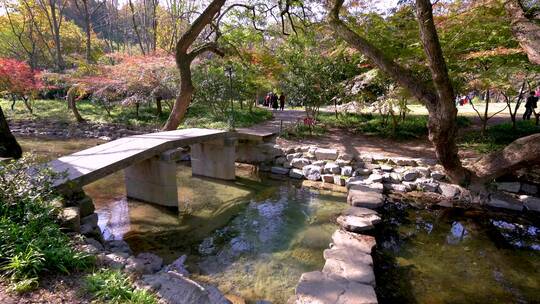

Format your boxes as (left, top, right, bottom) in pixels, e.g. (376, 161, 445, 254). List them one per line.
(329, 0, 469, 184)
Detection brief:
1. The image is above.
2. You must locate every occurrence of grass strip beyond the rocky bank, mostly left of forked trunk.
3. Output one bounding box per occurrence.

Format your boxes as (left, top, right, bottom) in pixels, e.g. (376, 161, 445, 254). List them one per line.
(319, 113, 471, 140)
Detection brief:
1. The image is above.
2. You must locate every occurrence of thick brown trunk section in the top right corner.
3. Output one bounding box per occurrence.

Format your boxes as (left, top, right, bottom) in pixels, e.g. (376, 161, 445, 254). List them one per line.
(504, 0, 540, 64)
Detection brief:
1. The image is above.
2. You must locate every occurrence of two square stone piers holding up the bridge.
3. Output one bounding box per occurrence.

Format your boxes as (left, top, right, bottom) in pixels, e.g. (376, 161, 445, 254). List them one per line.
(124, 136, 237, 208)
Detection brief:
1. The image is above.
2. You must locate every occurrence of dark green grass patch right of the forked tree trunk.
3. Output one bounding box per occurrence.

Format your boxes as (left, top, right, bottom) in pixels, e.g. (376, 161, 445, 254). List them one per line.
(459, 120, 540, 153)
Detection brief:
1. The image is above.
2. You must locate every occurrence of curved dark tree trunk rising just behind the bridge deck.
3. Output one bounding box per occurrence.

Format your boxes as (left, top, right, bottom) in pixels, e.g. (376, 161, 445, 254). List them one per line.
(163, 0, 225, 130)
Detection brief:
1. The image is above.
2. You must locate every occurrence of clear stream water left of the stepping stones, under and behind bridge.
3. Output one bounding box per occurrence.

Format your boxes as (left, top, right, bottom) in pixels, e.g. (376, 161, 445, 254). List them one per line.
(22, 140, 347, 303)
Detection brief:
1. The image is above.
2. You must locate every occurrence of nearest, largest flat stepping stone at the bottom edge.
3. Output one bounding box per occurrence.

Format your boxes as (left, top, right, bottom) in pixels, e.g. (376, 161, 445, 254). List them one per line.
(294, 271, 377, 304)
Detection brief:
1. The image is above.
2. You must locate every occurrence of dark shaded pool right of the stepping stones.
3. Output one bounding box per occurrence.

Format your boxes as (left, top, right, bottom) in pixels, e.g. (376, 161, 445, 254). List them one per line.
(374, 204, 540, 303)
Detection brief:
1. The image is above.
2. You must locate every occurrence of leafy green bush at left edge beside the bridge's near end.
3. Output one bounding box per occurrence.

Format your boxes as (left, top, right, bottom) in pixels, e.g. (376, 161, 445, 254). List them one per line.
(0, 159, 92, 291)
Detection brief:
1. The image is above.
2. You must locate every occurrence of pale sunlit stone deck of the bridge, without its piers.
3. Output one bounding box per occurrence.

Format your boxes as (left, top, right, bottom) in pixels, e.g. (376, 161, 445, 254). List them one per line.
(48, 129, 229, 186)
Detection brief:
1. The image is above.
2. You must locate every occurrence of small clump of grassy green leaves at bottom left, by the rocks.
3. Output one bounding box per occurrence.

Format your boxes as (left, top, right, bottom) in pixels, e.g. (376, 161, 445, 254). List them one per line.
(85, 269, 157, 304)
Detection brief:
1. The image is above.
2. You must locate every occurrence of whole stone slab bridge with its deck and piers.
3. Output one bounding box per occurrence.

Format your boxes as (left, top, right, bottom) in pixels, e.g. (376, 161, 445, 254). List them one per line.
(47, 129, 273, 207)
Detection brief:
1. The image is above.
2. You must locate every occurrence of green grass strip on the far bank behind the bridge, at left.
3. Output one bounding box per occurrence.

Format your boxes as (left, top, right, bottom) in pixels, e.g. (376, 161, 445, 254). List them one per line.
(0, 99, 272, 129)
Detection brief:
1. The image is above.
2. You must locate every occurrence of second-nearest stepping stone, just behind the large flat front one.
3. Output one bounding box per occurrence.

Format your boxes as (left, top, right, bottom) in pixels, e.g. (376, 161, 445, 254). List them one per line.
(322, 247, 375, 286)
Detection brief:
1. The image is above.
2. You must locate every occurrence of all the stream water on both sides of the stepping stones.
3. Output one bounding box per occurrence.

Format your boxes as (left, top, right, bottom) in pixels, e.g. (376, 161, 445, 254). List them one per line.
(22, 139, 540, 303)
